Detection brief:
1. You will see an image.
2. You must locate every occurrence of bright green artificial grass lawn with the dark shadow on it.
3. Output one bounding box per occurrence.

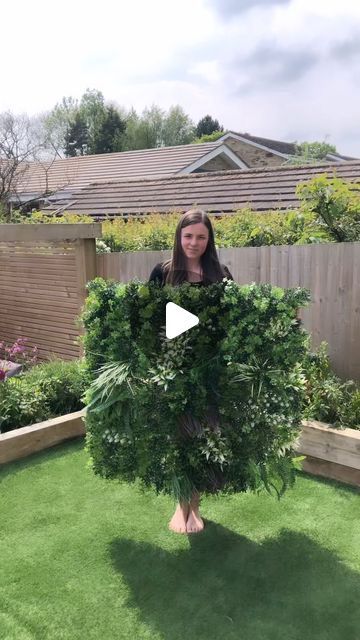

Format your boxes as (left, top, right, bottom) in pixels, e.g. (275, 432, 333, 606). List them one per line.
(0, 439, 360, 640)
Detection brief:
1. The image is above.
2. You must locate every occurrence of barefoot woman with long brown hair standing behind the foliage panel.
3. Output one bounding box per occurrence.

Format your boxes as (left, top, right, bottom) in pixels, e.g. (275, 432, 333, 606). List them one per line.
(149, 209, 233, 533)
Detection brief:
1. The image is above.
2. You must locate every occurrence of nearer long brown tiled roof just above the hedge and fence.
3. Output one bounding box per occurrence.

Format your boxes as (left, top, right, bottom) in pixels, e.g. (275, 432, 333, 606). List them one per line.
(44, 160, 360, 219)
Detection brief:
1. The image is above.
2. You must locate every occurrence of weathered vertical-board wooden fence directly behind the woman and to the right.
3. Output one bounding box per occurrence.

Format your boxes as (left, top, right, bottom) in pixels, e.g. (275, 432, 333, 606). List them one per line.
(97, 242, 360, 380)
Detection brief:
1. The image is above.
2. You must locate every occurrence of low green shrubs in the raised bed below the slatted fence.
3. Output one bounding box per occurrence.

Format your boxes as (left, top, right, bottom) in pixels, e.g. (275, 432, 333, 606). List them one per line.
(0, 360, 89, 433)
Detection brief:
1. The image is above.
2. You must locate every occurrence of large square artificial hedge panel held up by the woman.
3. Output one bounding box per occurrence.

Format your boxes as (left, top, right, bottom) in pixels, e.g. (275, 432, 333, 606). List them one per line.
(82, 278, 309, 500)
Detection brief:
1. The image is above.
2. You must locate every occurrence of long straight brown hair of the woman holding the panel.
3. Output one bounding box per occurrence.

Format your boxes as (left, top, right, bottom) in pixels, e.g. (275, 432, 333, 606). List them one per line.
(163, 209, 225, 285)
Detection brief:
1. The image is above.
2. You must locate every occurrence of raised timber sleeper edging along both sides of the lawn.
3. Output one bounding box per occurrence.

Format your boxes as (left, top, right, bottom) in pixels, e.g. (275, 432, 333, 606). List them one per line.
(0, 408, 360, 487)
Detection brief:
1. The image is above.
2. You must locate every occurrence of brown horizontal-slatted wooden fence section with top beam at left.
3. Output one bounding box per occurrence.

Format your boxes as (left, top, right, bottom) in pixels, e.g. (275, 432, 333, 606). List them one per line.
(0, 224, 101, 360)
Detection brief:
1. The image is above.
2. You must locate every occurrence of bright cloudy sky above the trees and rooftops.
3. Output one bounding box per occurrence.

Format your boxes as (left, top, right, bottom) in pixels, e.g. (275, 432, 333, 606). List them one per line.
(0, 0, 360, 157)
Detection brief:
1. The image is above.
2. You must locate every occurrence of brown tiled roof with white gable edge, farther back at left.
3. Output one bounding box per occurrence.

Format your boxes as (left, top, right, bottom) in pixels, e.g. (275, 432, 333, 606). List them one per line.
(17, 141, 240, 194)
